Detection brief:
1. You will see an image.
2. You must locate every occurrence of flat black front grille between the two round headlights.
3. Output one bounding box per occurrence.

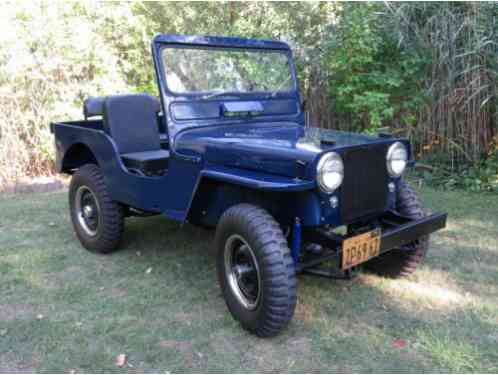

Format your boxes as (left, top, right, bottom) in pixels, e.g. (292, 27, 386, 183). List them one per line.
(340, 145, 388, 223)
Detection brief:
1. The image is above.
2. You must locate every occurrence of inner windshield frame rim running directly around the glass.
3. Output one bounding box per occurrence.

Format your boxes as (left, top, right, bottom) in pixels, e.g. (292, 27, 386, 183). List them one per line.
(158, 43, 298, 99)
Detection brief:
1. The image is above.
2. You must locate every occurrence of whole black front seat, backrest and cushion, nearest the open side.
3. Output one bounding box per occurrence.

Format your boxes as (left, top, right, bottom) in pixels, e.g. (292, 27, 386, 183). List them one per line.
(103, 94, 169, 176)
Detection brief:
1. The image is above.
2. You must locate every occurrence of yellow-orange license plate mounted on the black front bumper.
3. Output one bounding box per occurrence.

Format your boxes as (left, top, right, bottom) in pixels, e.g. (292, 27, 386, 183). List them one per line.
(341, 229, 380, 270)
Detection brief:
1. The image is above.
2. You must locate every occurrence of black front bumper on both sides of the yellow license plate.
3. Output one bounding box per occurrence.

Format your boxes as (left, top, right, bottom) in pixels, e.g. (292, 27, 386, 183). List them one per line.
(296, 212, 447, 272)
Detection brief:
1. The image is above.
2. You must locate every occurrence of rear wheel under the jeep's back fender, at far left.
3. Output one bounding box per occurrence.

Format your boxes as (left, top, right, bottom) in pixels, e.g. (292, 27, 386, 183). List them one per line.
(69, 164, 124, 253)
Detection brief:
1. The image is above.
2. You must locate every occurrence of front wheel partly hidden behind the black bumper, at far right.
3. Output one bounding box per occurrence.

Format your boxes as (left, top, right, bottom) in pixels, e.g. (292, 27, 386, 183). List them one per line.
(365, 182, 429, 278)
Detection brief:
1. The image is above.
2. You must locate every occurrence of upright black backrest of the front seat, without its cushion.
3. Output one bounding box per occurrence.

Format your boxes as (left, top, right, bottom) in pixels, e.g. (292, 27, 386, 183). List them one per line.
(104, 94, 161, 154)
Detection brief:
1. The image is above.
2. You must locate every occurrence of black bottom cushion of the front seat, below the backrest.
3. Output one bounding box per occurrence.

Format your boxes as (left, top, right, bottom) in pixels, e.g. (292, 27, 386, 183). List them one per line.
(121, 149, 169, 175)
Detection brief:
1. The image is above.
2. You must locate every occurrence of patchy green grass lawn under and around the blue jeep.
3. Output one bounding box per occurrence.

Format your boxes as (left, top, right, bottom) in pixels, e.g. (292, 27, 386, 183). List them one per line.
(0, 189, 498, 372)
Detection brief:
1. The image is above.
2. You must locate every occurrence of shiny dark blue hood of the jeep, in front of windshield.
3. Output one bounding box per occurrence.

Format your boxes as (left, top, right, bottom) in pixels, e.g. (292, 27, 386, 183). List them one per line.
(175, 123, 386, 179)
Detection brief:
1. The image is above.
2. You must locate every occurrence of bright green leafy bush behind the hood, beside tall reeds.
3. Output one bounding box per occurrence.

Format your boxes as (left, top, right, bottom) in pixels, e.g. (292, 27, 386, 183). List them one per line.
(326, 3, 424, 131)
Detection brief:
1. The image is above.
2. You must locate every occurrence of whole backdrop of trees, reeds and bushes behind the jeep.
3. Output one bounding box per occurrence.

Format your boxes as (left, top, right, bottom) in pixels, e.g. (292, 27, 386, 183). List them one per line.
(0, 2, 498, 191)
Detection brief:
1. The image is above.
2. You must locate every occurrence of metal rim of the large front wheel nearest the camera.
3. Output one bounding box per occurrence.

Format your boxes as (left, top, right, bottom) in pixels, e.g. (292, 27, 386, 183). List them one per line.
(225, 234, 261, 310)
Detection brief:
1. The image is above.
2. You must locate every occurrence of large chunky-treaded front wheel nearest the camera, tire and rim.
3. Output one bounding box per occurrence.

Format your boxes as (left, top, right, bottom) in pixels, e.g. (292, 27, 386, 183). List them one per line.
(215, 204, 297, 337)
